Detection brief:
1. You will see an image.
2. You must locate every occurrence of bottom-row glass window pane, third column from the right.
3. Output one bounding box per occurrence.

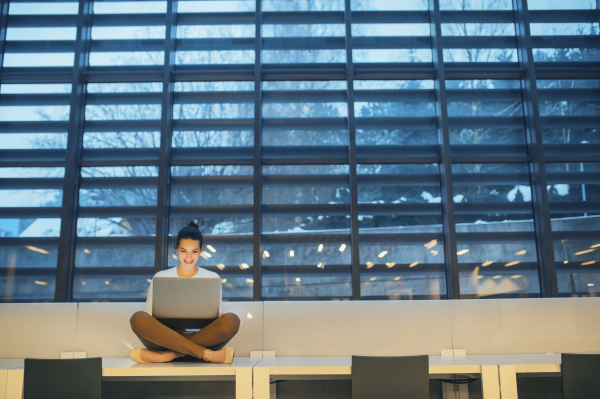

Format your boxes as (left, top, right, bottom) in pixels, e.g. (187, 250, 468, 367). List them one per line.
(357, 164, 446, 299)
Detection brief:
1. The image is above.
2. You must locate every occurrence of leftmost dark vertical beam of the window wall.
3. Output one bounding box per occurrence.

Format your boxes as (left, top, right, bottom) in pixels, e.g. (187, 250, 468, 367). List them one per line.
(54, 0, 94, 302)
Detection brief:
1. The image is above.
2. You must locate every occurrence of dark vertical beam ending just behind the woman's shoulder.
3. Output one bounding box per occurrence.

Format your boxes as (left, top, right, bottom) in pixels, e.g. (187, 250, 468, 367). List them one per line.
(154, 0, 177, 273)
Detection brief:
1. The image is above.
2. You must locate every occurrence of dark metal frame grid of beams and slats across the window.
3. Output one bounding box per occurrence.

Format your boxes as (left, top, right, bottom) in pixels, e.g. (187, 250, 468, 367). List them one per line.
(0, 0, 600, 302)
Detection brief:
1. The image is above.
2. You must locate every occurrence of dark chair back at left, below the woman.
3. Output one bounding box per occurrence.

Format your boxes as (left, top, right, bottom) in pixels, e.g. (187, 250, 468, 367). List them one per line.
(23, 357, 102, 399)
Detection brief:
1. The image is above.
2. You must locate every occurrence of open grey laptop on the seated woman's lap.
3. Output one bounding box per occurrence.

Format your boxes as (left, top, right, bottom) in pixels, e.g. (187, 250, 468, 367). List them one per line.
(152, 277, 221, 329)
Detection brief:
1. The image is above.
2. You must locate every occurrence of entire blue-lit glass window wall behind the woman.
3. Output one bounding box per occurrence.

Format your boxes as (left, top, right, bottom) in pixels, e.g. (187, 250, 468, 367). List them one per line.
(0, 0, 600, 302)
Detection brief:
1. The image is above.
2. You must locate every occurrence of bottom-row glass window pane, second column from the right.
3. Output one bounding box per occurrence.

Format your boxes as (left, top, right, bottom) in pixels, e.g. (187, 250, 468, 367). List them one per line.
(452, 163, 540, 298)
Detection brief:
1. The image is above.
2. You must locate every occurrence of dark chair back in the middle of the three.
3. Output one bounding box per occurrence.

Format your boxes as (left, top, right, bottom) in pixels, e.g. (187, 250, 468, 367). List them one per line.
(352, 355, 429, 399)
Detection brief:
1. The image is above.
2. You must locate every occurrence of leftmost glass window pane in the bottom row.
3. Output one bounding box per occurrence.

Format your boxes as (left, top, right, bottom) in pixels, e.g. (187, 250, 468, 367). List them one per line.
(0, 167, 64, 302)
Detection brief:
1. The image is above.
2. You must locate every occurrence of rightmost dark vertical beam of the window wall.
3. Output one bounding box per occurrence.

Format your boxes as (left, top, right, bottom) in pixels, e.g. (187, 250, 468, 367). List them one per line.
(513, 0, 558, 297)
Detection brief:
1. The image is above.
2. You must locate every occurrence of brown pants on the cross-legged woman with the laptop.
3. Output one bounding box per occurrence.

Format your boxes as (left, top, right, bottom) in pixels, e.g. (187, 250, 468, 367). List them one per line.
(130, 311, 240, 359)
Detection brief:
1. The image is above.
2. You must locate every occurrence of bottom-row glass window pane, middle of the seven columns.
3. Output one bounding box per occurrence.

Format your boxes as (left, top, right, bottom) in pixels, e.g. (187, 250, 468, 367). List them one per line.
(262, 165, 352, 300)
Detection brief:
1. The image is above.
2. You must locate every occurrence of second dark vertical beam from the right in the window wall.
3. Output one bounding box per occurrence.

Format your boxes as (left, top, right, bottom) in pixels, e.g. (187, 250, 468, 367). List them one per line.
(429, 0, 460, 299)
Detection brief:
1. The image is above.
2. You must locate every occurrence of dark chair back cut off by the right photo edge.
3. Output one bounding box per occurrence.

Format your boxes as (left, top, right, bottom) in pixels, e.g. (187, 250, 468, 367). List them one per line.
(561, 353, 600, 399)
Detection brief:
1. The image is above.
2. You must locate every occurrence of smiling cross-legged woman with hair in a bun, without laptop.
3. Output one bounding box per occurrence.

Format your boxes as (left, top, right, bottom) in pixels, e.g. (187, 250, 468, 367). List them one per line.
(129, 222, 240, 364)
